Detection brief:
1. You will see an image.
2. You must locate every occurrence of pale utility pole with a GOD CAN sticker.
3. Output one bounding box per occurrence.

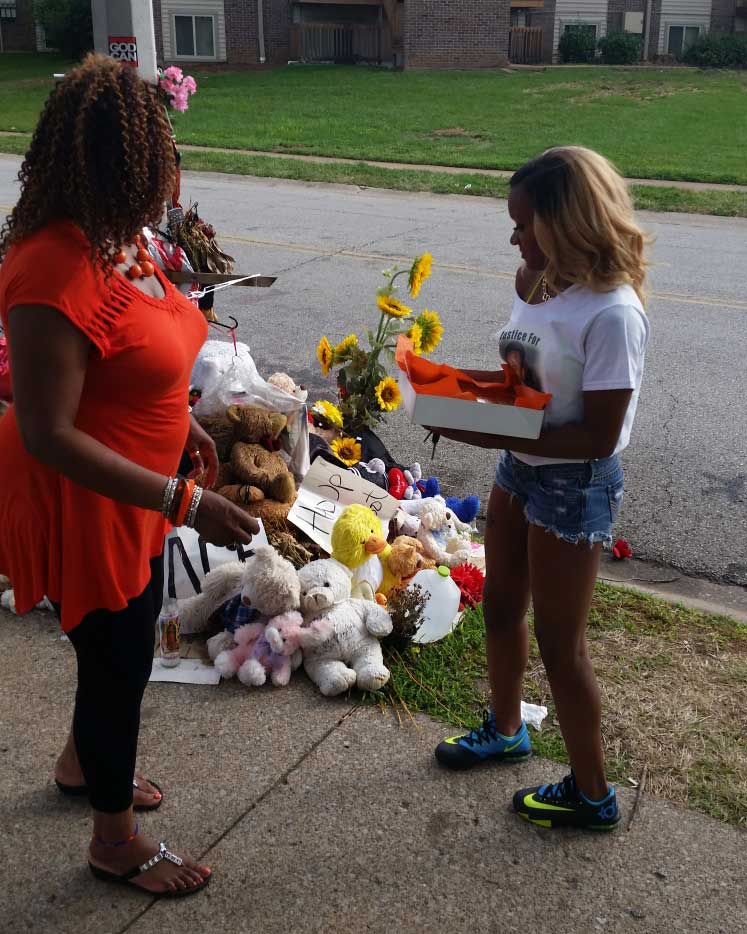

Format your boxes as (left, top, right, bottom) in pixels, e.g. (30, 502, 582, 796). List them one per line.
(91, 0, 157, 83)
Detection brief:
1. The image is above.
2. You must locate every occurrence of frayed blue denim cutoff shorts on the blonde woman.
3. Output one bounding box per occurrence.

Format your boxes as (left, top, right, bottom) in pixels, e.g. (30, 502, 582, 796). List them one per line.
(495, 451, 623, 546)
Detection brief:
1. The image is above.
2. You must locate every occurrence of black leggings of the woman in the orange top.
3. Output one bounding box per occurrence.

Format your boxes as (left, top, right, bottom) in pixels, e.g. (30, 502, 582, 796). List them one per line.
(60, 557, 163, 814)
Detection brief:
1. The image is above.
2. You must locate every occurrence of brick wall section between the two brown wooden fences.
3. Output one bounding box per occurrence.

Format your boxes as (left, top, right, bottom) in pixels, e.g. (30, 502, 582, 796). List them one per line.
(405, 0, 511, 68)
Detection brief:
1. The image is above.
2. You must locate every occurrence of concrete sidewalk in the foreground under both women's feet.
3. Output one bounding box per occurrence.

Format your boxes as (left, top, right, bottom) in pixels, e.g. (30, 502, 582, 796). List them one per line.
(0, 613, 747, 934)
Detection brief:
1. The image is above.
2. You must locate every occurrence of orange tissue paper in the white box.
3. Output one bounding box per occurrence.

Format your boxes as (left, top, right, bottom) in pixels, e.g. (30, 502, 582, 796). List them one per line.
(395, 334, 552, 410)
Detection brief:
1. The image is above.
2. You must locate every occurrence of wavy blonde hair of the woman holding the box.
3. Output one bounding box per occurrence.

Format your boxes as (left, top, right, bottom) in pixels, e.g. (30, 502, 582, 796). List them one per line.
(510, 146, 649, 302)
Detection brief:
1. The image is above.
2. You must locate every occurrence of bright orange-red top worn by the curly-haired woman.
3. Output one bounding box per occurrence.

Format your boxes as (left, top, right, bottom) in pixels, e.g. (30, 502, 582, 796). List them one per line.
(0, 221, 207, 632)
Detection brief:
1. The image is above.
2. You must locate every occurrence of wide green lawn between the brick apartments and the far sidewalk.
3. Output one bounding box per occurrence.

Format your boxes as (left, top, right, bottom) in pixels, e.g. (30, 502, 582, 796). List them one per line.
(0, 55, 747, 183)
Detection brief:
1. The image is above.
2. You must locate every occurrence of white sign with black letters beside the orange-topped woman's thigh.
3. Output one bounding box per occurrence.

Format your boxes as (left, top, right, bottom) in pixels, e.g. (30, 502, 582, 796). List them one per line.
(163, 520, 269, 600)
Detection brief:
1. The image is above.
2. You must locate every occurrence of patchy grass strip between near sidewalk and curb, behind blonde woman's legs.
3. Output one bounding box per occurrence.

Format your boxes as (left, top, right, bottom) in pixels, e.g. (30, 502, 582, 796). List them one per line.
(386, 583, 747, 828)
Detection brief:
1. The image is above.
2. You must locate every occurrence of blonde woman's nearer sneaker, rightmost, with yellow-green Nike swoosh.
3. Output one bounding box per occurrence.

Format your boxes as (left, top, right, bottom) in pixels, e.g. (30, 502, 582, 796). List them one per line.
(513, 772, 621, 830)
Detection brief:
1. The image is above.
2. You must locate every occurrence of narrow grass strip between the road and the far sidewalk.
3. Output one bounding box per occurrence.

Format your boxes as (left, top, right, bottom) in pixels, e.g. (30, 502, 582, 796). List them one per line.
(0, 136, 747, 217)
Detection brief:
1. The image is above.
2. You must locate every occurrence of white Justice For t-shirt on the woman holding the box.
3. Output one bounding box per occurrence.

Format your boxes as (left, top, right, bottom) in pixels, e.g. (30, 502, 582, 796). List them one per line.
(498, 285, 649, 466)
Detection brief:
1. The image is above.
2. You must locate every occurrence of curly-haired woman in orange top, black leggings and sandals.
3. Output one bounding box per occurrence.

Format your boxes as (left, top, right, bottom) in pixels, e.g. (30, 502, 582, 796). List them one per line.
(0, 56, 257, 895)
